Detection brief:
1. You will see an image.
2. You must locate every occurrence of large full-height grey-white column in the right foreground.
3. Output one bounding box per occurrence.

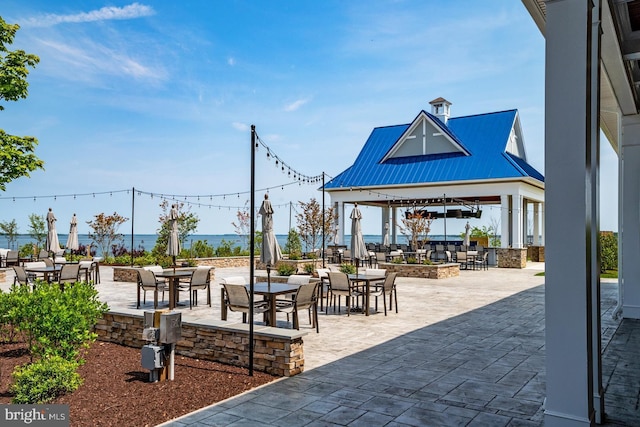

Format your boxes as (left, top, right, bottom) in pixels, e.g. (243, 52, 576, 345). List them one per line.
(544, 0, 599, 427)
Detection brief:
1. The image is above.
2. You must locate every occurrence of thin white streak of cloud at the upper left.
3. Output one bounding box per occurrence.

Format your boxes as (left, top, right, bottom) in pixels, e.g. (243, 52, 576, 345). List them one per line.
(24, 3, 155, 27)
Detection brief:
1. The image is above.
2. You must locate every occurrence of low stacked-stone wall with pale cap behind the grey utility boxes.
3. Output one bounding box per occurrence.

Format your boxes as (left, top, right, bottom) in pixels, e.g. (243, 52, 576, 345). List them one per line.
(95, 312, 307, 377)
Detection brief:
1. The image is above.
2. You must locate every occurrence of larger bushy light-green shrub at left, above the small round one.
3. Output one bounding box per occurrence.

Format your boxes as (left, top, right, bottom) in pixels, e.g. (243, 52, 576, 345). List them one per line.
(11, 282, 108, 360)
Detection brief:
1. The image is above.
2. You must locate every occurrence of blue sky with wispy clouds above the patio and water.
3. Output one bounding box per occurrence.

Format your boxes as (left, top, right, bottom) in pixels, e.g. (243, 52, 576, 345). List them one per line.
(0, 0, 617, 234)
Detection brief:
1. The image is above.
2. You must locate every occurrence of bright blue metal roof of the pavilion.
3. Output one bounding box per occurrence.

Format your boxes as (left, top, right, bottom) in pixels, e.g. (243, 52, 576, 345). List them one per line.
(325, 110, 544, 189)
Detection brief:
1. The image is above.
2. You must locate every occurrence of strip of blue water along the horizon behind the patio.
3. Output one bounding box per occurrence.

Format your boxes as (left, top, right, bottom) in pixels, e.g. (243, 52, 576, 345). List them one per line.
(0, 233, 460, 251)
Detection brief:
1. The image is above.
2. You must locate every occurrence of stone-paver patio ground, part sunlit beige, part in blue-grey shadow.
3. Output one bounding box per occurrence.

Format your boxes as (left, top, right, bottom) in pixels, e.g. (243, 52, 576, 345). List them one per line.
(0, 263, 640, 427)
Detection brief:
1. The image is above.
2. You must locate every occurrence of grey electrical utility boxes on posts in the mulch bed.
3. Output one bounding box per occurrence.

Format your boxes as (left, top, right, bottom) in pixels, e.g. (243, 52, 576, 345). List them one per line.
(141, 310, 182, 382)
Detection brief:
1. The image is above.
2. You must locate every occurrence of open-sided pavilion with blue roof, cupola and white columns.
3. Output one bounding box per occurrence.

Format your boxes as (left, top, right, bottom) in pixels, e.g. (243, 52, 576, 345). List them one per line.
(325, 98, 544, 248)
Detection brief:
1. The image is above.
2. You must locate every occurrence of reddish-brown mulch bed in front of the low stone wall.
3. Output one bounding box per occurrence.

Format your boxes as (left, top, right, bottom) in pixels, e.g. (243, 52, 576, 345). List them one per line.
(0, 342, 276, 427)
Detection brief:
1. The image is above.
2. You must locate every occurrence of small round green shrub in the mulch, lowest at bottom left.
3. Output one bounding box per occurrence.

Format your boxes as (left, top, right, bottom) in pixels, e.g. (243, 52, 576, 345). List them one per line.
(11, 356, 82, 404)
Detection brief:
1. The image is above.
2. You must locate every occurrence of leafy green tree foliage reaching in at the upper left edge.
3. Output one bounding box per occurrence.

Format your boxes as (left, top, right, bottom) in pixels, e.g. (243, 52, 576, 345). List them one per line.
(0, 17, 44, 191)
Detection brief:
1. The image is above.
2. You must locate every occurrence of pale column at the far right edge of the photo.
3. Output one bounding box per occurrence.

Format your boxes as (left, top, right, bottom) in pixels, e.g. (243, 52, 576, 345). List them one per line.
(619, 116, 640, 319)
